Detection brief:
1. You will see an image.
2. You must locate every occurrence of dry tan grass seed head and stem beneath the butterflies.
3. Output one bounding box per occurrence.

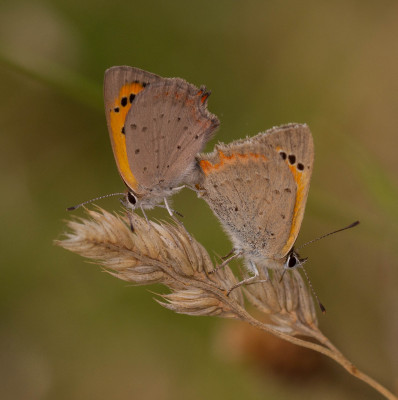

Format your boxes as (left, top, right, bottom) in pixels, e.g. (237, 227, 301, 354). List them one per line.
(56, 209, 397, 400)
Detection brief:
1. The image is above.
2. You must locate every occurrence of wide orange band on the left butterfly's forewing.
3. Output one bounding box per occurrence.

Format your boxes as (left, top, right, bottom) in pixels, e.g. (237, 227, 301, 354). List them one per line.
(107, 82, 144, 190)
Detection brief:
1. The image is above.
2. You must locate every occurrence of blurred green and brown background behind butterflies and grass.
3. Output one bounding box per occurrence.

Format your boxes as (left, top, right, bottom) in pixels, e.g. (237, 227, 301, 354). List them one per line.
(0, 0, 398, 400)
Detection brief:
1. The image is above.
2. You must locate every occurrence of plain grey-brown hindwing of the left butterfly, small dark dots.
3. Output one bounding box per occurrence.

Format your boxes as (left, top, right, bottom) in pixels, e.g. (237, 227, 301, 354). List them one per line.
(125, 78, 219, 193)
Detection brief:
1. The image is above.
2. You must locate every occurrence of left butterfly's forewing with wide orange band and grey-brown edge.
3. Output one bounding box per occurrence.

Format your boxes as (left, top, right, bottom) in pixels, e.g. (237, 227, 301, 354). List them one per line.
(104, 66, 163, 191)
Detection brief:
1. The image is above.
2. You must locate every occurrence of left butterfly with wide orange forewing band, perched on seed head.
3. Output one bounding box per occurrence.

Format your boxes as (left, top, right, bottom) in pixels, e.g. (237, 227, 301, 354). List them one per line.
(104, 66, 219, 222)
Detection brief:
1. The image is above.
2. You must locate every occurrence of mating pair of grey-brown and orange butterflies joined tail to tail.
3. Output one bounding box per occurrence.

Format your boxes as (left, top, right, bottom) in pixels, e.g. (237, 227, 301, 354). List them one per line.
(75, 66, 358, 304)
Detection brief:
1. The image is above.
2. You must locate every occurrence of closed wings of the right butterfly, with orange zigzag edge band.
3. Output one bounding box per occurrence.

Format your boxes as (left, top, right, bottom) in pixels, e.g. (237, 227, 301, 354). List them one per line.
(198, 124, 314, 259)
